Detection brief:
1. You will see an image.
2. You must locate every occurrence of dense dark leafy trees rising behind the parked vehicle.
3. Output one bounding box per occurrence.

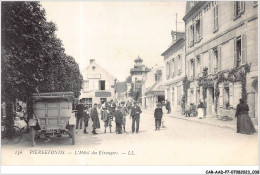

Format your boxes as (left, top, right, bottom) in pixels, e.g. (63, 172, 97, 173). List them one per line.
(1, 1, 82, 134)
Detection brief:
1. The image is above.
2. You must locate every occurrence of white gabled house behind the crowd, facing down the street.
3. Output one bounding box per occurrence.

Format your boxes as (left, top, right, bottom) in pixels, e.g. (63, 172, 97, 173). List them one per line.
(80, 59, 115, 107)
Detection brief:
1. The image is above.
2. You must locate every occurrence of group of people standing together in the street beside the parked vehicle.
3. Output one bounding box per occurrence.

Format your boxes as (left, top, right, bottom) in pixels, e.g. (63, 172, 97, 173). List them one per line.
(76, 100, 142, 134)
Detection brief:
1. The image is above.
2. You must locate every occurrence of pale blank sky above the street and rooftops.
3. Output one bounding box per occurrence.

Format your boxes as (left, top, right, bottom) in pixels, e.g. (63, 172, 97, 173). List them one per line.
(41, 1, 186, 81)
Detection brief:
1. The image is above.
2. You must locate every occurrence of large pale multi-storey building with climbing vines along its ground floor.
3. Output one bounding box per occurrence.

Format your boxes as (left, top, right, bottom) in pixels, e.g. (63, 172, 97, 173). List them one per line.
(183, 1, 258, 123)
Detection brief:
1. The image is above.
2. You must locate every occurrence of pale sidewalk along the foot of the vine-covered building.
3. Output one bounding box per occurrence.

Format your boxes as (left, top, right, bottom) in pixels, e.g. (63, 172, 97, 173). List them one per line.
(144, 110, 258, 132)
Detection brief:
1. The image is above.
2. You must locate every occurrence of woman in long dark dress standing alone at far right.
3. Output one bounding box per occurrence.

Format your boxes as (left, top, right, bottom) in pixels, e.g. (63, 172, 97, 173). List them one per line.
(235, 98, 256, 134)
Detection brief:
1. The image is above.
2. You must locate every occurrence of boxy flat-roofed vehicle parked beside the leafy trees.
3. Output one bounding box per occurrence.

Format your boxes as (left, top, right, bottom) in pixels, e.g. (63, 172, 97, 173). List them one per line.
(29, 92, 76, 146)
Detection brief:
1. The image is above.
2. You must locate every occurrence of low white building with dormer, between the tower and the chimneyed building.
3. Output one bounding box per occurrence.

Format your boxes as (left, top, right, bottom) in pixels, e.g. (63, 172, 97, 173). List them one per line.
(142, 66, 165, 109)
